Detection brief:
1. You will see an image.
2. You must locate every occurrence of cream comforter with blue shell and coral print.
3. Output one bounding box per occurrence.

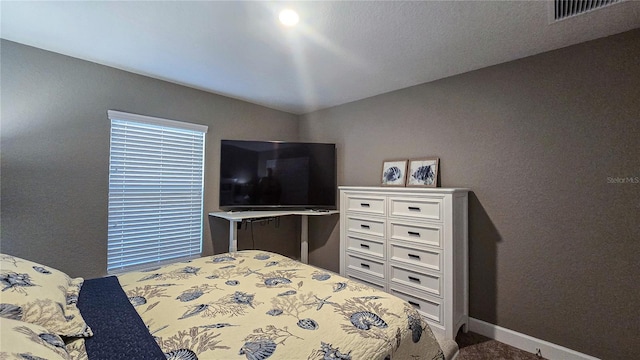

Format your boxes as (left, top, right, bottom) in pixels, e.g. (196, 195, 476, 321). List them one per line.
(118, 250, 444, 360)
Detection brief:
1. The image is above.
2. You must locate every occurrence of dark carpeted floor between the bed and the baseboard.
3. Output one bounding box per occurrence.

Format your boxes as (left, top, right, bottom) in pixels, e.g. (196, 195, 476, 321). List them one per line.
(456, 331, 543, 360)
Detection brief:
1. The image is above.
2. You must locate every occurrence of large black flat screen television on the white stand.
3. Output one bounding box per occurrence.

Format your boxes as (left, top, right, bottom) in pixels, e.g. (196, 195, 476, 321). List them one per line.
(219, 140, 337, 211)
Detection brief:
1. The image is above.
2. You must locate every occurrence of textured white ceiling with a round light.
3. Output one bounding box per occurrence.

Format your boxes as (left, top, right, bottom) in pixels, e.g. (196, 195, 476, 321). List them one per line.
(0, 0, 640, 114)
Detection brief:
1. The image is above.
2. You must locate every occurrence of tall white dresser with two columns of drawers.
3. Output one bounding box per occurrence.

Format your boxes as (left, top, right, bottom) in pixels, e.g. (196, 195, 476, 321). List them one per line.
(339, 186, 469, 339)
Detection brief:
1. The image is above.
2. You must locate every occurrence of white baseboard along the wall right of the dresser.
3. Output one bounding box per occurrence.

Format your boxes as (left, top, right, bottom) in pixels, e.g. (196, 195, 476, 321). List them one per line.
(469, 317, 600, 360)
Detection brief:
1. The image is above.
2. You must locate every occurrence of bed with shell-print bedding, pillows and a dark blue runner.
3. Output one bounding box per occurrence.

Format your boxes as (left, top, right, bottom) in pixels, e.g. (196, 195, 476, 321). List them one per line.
(0, 250, 445, 360)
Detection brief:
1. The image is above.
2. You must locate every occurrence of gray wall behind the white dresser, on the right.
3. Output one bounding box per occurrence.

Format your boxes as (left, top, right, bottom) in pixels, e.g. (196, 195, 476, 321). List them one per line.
(301, 30, 640, 359)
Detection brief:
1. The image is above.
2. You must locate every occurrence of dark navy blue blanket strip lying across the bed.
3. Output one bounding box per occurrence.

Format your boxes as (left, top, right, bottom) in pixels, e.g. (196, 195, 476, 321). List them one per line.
(78, 276, 166, 360)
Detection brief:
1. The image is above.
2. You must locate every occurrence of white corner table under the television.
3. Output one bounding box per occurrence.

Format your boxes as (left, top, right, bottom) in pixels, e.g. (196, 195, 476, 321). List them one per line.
(209, 210, 340, 264)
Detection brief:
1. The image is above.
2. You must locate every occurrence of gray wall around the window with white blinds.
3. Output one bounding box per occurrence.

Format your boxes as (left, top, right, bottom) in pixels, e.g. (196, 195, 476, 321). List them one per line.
(0, 40, 299, 278)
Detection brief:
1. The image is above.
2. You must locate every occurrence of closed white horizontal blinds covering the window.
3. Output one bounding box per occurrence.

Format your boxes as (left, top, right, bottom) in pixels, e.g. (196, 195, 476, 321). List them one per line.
(107, 110, 207, 272)
